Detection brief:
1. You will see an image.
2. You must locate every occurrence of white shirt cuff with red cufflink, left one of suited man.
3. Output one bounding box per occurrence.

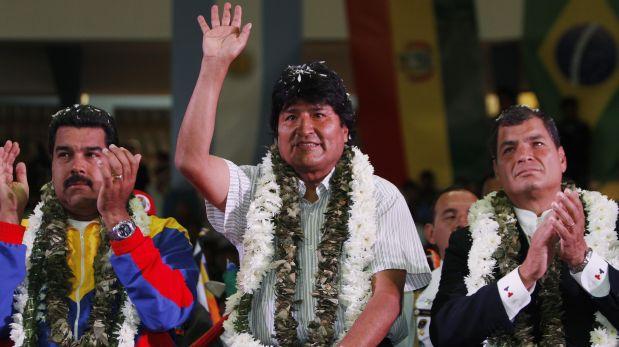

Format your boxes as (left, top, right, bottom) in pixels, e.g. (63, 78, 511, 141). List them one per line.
(497, 267, 535, 321)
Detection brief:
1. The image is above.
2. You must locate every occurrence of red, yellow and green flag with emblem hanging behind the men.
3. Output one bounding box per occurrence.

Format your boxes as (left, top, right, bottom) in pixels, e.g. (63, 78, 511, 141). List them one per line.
(347, 0, 488, 186)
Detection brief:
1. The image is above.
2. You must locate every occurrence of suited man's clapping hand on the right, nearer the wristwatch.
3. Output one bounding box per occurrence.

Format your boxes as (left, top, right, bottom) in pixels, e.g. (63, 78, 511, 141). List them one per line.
(552, 189, 587, 267)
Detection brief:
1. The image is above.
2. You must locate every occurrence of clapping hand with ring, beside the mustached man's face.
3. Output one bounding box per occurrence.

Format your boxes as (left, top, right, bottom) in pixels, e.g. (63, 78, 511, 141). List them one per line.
(97, 145, 142, 228)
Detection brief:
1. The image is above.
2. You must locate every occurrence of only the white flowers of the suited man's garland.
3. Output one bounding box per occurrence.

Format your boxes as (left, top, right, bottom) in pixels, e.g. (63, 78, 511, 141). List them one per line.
(464, 189, 619, 347)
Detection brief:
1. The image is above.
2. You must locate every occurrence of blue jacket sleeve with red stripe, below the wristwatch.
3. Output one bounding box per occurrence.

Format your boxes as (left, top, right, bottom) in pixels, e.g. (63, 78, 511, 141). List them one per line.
(110, 218, 198, 331)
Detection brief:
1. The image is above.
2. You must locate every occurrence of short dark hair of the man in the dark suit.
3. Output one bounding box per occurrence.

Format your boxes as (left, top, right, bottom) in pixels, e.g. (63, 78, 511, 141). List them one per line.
(488, 105, 561, 160)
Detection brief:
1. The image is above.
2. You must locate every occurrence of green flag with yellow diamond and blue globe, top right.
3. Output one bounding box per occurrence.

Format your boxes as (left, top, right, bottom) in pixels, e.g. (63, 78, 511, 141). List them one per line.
(524, 0, 619, 195)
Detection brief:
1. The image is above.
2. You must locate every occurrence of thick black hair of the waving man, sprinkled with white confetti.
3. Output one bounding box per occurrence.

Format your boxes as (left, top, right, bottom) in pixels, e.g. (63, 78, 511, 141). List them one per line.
(270, 61, 355, 143)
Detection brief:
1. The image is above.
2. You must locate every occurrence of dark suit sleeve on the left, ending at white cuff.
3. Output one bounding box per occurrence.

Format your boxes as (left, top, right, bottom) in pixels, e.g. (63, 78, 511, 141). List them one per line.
(430, 229, 512, 346)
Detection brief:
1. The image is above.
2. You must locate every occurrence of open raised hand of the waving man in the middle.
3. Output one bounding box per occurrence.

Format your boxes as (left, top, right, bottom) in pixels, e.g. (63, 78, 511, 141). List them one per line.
(198, 2, 251, 63)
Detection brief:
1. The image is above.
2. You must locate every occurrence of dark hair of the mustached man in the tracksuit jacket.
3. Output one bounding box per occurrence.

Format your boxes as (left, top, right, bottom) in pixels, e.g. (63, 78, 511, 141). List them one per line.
(48, 104, 118, 153)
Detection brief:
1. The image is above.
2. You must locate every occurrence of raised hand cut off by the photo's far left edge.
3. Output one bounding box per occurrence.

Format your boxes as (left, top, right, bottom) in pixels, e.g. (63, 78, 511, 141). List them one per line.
(0, 140, 30, 224)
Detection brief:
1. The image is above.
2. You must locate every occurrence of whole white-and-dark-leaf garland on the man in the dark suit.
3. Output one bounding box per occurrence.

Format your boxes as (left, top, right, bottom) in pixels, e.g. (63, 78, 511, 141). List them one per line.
(464, 189, 619, 346)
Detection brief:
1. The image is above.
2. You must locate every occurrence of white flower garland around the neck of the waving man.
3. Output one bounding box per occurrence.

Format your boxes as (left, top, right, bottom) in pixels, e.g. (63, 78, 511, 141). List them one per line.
(221, 147, 377, 347)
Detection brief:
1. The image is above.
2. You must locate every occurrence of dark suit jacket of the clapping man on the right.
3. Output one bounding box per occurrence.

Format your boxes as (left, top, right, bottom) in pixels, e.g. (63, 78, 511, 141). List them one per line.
(430, 227, 619, 346)
